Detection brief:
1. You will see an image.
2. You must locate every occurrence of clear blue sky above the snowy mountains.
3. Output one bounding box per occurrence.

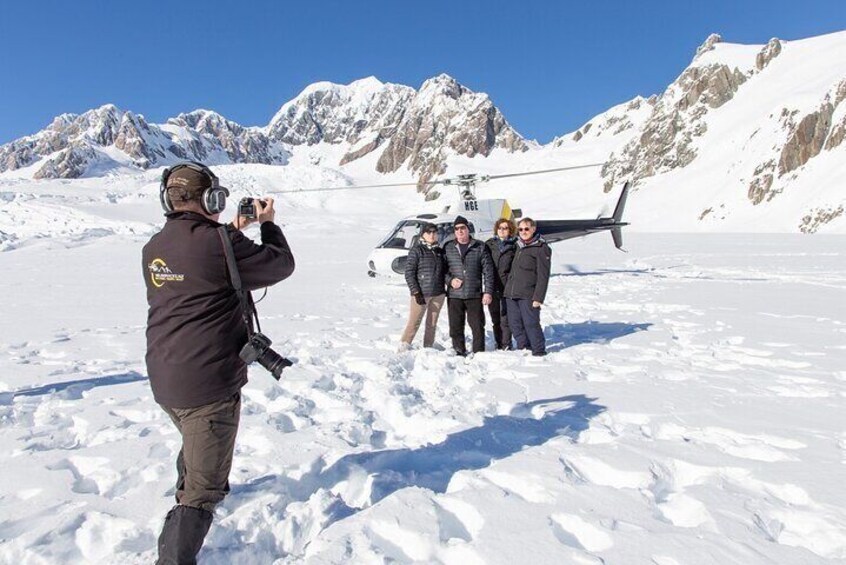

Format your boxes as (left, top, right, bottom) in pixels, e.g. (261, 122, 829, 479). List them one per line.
(0, 0, 846, 144)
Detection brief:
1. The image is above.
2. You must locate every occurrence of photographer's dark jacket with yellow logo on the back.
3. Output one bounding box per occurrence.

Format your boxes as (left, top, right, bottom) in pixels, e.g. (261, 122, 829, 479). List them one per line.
(142, 212, 294, 408)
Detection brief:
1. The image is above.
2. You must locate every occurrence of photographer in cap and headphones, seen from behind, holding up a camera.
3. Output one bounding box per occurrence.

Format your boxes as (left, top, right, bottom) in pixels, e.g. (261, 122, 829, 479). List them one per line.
(142, 163, 294, 564)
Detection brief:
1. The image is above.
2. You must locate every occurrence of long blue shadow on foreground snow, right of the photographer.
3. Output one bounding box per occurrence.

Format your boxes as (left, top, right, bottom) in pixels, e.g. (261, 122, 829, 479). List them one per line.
(309, 394, 605, 506)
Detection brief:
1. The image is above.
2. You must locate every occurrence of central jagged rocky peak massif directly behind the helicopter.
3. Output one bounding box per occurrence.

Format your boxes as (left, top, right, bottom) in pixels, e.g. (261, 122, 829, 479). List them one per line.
(268, 75, 528, 184)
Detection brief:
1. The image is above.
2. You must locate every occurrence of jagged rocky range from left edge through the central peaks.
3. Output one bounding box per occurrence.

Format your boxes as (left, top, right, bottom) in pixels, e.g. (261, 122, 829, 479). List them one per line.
(0, 75, 528, 182)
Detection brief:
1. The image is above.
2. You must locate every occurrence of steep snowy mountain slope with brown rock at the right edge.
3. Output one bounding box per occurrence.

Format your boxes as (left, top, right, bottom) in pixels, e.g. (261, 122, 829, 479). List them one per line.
(553, 32, 846, 233)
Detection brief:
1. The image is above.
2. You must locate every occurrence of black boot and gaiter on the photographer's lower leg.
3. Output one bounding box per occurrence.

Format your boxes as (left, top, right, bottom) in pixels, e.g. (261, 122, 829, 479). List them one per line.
(156, 505, 212, 565)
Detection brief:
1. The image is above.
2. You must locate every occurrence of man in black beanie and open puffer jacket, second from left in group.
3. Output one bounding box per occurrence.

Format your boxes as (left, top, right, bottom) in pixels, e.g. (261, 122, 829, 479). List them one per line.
(444, 216, 494, 356)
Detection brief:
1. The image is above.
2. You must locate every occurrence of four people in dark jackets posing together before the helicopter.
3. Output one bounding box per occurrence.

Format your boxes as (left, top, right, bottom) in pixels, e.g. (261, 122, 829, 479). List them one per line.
(400, 216, 552, 356)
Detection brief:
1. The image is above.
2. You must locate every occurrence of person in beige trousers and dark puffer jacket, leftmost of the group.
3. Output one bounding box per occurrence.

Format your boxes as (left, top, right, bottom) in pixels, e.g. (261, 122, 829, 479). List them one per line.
(400, 224, 446, 351)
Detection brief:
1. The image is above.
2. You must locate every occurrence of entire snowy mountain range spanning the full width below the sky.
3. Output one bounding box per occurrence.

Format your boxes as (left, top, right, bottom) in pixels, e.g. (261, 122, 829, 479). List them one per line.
(0, 32, 846, 232)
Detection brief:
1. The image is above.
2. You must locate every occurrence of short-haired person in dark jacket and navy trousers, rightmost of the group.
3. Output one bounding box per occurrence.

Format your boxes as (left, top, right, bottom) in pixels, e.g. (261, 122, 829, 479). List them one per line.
(505, 218, 552, 356)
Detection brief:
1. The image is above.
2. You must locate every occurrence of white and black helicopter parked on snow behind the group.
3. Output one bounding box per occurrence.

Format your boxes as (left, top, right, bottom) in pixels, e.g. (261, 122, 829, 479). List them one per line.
(367, 165, 630, 277)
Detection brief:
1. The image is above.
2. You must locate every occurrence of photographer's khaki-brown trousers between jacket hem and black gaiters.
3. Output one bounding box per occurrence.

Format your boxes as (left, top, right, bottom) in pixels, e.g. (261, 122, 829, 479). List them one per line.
(162, 393, 241, 512)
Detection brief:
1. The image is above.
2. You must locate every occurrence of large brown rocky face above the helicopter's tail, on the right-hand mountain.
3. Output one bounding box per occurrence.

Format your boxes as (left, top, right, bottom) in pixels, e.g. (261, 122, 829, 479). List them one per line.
(602, 59, 746, 192)
